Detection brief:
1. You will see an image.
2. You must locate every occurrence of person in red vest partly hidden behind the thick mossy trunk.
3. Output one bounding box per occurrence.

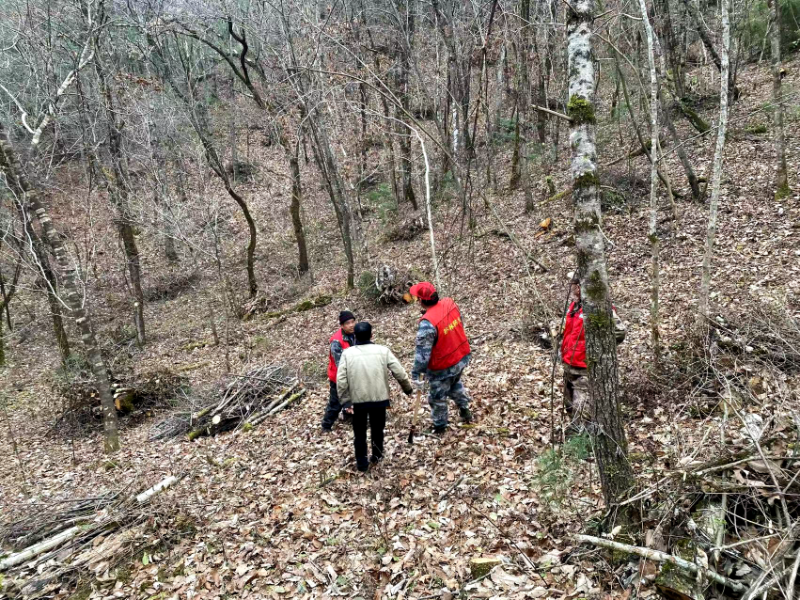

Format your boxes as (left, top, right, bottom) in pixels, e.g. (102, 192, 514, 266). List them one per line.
(559, 275, 625, 431)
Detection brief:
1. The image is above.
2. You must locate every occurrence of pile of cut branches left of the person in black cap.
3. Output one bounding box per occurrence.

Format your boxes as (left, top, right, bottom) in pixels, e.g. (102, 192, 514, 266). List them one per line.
(150, 365, 306, 440)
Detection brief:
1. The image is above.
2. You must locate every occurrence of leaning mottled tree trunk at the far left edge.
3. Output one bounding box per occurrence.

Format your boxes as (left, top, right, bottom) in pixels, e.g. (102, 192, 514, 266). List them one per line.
(0, 122, 119, 453)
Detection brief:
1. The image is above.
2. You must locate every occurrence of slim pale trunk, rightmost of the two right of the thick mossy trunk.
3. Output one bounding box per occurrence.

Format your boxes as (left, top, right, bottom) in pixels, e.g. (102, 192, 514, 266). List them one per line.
(696, 0, 731, 333)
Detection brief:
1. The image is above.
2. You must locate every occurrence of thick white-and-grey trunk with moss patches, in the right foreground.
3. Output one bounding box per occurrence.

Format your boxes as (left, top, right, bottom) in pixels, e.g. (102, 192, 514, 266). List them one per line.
(567, 0, 633, 504)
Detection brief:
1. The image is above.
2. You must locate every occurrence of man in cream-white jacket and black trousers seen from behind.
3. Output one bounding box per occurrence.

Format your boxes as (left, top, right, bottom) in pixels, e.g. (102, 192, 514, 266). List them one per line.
(336, 321, 413, 473)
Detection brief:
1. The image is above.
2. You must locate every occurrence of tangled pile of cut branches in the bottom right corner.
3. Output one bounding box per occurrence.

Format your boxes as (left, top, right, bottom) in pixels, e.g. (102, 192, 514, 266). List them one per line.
(576, 426, 800, 600)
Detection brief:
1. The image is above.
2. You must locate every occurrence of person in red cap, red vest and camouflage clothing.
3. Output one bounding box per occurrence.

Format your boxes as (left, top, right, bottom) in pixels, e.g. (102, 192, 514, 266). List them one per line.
(409, 281, 472, 434)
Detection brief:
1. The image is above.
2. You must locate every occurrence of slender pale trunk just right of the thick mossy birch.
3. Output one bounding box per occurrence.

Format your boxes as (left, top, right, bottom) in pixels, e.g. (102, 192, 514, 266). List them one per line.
(639, 0, 661, 366)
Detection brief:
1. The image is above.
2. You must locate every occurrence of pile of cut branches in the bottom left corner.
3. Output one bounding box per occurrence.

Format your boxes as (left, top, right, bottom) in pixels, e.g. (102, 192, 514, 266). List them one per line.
(0, 475, 183, 598)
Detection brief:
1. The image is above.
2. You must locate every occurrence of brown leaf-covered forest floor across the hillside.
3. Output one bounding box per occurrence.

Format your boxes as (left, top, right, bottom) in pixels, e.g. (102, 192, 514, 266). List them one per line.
(0, 59, 800, 599)
